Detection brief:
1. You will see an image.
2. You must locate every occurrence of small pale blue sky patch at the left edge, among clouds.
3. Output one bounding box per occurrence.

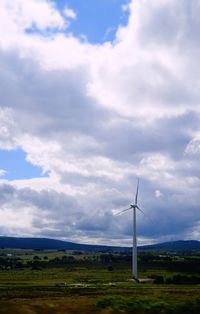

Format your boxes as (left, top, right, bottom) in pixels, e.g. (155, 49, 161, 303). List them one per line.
(0, 149, 48, 180)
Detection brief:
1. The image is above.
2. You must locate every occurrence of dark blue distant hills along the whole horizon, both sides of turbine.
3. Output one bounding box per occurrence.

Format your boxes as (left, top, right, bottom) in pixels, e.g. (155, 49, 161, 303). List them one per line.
(0, 236, 200, 252)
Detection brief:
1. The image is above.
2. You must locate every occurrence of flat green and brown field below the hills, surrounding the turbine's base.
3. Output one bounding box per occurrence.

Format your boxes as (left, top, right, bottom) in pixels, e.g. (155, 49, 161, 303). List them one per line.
(0, 249, 200, 314)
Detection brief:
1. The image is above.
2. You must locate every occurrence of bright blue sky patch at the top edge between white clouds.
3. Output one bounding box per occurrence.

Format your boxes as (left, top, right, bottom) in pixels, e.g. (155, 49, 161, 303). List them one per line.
(26, 0, 130, 44)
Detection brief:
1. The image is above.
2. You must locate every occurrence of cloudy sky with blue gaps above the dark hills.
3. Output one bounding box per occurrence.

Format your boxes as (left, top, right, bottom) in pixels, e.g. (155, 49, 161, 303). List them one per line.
(0, 0, 200, 245)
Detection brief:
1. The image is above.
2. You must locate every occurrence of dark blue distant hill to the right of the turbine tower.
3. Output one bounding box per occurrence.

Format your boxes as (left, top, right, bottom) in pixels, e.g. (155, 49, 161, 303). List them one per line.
(139, 240, 200, 251)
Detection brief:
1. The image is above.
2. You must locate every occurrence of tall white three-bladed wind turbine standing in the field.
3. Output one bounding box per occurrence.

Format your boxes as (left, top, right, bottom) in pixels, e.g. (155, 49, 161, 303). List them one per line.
(116, 179, 144, 282)
